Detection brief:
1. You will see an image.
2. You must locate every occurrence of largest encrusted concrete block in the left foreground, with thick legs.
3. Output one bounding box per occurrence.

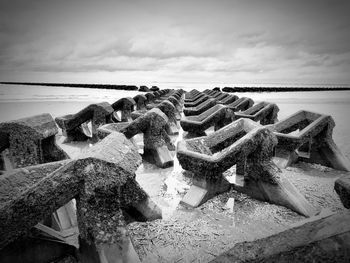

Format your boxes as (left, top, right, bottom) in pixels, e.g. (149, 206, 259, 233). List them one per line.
(0, 133, 161, 262)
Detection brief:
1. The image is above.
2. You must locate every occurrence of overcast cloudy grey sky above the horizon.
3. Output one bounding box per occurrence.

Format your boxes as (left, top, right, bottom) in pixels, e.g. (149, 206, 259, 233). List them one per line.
(0, 0, 350, 84)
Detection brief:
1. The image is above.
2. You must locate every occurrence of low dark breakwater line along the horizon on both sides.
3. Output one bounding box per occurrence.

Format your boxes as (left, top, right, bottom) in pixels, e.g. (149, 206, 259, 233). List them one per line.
(0, 82, 350, 92)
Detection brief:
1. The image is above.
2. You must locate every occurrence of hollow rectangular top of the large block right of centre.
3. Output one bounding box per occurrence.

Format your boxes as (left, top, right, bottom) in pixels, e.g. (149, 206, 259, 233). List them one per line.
(177, 119, 277, 176)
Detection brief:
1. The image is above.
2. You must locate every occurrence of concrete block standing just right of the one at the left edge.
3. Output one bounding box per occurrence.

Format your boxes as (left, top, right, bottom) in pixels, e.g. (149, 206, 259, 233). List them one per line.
(55, 102, 113, 142)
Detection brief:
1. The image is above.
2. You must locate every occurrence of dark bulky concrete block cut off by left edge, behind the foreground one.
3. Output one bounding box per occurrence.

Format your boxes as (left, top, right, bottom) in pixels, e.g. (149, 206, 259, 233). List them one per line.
(0, 113, 67, 168)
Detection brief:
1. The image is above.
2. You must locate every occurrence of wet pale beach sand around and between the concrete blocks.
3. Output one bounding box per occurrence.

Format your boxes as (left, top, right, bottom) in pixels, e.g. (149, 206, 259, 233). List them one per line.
(0, 86, 350, 262)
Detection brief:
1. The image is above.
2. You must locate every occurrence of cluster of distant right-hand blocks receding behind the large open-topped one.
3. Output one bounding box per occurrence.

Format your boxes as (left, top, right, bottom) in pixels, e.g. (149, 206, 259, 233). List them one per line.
(180, 90, 279, 137)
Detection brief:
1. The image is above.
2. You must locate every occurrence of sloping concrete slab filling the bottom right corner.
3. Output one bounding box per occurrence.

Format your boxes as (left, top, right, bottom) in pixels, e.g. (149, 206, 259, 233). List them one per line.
(211, 211, 350, 263)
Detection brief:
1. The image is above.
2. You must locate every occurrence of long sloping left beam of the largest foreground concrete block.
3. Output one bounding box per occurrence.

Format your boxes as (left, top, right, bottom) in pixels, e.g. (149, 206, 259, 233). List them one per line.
(0, 161, 80, 249)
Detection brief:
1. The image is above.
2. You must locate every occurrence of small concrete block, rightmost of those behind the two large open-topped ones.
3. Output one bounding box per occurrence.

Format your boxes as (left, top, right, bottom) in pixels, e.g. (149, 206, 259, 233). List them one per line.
(236, 101, 279, 125)
